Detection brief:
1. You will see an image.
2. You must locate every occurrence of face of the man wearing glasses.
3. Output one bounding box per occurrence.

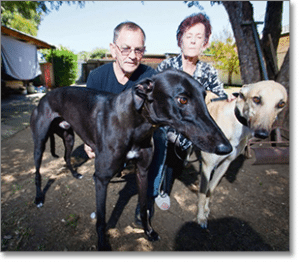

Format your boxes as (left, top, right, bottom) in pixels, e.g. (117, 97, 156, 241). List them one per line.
(111, 28, 144, 74)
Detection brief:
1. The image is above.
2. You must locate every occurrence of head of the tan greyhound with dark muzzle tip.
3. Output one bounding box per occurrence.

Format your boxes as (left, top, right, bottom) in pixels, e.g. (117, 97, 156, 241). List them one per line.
(235, 80, 287, 138)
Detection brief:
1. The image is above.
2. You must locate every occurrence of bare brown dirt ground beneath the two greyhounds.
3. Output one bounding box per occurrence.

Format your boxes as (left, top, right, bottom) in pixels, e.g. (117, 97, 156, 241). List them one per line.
(1, 124, 289, 251)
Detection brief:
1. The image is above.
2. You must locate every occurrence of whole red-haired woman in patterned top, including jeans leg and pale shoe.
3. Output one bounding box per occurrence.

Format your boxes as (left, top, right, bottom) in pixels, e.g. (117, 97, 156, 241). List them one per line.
(148, 13, 234, 215)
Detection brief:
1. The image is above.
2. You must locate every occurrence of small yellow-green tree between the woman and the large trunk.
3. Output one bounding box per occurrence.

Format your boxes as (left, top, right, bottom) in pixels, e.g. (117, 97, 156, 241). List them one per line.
(209, 37, 240, 85)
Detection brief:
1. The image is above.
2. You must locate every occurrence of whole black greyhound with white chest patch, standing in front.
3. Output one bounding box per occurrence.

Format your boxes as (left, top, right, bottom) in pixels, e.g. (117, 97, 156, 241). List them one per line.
(30, 69, 232, 250)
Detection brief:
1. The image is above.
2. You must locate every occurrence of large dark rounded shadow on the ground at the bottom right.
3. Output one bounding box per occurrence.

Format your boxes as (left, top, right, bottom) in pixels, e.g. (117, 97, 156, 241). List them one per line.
(174, 217, 272, 251)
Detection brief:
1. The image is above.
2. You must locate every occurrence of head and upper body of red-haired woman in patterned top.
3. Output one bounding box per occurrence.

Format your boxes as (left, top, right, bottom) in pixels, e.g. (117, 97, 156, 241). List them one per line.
(156, 13, 234, 101)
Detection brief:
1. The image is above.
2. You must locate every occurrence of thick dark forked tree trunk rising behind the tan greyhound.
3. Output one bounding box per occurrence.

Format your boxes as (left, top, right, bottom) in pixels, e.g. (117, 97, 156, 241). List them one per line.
(184, 1, 289, 84)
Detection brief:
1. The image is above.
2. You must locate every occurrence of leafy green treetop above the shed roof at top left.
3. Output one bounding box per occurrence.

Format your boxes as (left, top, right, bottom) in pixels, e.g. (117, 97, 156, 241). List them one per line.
(1, 1, 85, 36)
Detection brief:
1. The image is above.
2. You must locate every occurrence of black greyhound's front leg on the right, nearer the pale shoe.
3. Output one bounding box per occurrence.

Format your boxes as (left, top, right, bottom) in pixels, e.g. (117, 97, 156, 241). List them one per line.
(136, 148, 159, 241)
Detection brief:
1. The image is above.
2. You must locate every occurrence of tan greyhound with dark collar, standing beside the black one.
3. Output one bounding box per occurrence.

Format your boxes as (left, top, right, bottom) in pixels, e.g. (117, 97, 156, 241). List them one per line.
(197, 81, 287, 228)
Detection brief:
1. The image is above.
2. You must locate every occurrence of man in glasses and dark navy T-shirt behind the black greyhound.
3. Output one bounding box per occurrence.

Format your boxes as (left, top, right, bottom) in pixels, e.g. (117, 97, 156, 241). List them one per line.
(84, 22, 156, 225)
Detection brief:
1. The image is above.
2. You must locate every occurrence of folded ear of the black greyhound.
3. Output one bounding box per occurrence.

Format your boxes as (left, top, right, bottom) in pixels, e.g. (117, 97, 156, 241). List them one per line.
(132, 78, 154, 110)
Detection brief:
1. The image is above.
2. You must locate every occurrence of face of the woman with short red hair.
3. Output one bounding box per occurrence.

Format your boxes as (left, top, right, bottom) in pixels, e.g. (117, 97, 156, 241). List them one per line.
(180, 23, 207, 57)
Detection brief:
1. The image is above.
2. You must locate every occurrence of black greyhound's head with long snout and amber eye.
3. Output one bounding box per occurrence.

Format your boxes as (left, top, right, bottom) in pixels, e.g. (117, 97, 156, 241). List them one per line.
(133, 69, 232, 154)
